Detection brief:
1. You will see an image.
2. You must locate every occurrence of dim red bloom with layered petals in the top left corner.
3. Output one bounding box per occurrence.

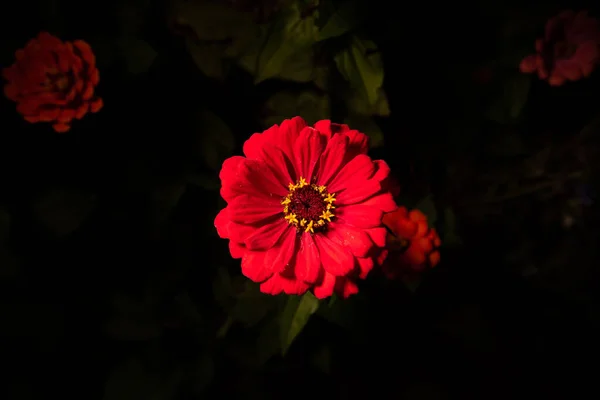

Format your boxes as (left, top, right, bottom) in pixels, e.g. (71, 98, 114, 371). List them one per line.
(2, 32, 103, 133)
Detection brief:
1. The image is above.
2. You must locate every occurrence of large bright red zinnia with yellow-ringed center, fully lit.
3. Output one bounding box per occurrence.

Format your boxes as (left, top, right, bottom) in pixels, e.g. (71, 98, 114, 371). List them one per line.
(215, 117, 396, 298)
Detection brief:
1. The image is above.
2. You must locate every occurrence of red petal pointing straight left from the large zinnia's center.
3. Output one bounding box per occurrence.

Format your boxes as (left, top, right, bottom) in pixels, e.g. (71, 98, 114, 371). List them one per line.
(227, 194, 283, 224)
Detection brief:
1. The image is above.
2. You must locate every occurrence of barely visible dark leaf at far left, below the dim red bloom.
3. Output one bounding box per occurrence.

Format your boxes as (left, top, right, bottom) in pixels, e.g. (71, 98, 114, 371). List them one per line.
(33, 190, 96, 238)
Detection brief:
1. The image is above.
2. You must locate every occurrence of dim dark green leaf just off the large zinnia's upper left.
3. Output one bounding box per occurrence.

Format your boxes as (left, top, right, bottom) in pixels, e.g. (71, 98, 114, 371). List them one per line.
(196, 110, 235, 171)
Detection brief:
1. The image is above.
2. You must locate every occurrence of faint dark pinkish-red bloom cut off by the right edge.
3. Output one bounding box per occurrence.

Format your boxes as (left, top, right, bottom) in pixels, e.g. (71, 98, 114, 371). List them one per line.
(520, 10, 600, 86)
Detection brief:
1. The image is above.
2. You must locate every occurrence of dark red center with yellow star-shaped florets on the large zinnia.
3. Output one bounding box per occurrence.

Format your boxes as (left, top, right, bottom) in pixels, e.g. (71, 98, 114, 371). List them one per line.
(281, 177, 335, 233)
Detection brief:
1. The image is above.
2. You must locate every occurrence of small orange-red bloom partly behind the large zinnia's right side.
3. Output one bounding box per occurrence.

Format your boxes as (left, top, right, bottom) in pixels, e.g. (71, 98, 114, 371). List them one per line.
(382, 207, 441, 279)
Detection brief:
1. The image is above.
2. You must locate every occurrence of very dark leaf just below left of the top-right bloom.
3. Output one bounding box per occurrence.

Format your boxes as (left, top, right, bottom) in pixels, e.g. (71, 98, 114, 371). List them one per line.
(485, 74, 531, 124)
